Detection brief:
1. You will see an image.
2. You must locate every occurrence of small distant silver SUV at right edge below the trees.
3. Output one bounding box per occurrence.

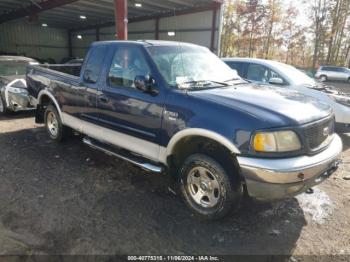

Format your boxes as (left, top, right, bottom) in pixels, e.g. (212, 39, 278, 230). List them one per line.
(315, 66, 350, 83)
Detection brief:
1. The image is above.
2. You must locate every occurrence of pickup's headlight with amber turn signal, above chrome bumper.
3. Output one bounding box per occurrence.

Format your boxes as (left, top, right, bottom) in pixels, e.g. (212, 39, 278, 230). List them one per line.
(253, 131, 301, 152)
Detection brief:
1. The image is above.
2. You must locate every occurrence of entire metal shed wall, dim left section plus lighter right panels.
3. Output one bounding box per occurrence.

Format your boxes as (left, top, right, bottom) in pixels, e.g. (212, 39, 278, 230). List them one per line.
(0, 8, 220, 62)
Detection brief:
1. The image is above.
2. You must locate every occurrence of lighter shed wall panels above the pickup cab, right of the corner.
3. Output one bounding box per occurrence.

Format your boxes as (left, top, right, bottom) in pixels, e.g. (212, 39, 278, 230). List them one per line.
(72, 10, 220, 57)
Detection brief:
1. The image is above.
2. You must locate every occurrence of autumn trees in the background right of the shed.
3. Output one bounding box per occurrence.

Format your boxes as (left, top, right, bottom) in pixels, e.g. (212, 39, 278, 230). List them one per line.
(220, 0, 350, 69)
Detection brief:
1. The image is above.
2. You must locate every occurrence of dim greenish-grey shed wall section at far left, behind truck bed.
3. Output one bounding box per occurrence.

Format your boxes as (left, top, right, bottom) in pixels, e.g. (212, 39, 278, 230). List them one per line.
(0, 21, 68, 62)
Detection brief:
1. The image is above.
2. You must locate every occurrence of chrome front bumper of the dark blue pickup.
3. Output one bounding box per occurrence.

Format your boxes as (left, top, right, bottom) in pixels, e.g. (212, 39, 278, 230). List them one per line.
(238, 134, 343, 200)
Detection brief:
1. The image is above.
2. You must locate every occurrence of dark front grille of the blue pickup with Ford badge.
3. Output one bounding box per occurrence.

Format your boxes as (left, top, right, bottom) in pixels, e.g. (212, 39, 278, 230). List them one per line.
(305, 118, 334, 151)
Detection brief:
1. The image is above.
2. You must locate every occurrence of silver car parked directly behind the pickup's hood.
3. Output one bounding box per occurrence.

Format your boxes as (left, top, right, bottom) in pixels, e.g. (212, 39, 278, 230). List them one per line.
(223, 58, 350, 132)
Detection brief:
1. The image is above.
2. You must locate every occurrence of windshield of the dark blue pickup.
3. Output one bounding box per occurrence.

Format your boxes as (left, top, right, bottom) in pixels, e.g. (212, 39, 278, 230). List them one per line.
(148, 45, 242, 89)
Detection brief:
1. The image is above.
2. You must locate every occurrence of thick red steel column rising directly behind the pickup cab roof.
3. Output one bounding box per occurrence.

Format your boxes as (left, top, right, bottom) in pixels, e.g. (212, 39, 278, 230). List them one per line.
(114, 0, 128, 40)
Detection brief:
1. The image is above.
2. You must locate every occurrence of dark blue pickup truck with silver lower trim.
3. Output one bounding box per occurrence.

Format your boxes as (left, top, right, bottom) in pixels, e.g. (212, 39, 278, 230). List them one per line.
(27, 41, 342, 219)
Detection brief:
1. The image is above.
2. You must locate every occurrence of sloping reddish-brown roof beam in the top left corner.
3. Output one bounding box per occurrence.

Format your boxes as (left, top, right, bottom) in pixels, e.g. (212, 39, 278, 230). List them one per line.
(0, 0, 78, 24)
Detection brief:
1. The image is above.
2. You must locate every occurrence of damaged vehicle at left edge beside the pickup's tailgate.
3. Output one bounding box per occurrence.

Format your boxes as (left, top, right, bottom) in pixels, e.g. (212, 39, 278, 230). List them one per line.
(0, 56, 38, 113)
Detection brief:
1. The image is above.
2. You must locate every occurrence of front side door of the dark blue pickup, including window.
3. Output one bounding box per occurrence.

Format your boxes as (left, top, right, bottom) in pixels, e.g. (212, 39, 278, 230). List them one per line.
(97, 44, 164, 147)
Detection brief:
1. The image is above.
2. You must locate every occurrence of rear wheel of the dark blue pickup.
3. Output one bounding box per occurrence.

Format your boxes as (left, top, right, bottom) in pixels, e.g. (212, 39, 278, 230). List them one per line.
(44, 104, 68, 143)
